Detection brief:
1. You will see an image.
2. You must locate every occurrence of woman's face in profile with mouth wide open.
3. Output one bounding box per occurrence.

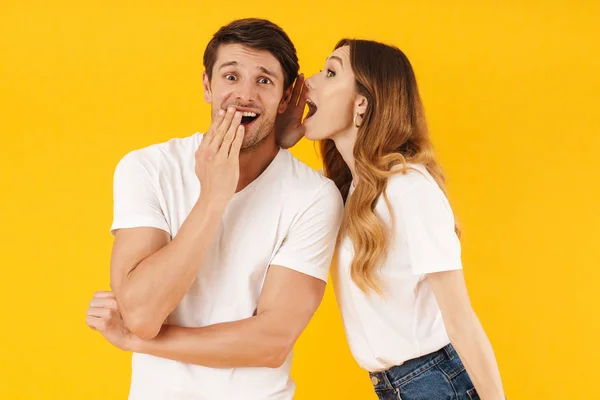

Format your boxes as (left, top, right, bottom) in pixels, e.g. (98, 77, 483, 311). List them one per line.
(303, 46, 356, 140)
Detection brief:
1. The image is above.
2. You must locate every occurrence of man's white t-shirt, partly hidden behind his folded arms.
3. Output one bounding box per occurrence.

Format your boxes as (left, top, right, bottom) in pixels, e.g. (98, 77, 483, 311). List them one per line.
(111, 133, 343, 400)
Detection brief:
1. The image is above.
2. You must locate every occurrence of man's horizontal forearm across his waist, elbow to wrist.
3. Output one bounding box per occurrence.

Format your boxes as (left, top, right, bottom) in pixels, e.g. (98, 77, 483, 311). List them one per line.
(127, 314, 293, 368)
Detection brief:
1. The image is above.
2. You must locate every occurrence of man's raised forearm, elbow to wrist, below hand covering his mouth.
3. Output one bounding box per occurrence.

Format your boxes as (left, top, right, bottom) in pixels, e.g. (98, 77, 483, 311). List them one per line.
(116, 197, 225, 338)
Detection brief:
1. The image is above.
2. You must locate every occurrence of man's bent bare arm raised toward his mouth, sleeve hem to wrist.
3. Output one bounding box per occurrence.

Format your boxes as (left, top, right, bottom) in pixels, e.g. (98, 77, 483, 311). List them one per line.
(111, 199, 224, 338)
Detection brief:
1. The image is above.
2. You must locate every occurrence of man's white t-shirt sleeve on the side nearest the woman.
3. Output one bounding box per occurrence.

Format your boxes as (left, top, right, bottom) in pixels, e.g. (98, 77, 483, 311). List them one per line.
(271, 181, 344, 282)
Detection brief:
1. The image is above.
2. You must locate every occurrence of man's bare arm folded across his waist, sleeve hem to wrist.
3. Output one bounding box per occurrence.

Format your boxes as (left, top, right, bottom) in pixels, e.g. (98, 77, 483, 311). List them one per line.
(127, 265, 326, 368)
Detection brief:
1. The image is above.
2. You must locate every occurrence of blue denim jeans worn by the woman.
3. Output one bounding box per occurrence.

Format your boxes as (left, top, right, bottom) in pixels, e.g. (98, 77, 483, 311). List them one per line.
(369, 344, 479, 400)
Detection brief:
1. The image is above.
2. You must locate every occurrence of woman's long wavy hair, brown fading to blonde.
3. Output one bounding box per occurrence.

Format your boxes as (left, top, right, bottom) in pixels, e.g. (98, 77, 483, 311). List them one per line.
(321, 39, 458, 294)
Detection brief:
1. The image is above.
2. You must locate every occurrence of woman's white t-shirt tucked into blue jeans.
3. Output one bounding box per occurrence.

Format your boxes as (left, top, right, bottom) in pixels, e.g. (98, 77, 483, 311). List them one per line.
(331, 165, 462, 372)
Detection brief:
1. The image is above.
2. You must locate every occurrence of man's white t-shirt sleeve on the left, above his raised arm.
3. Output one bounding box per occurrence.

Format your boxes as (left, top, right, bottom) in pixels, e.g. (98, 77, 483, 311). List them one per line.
(110, 152, 171, 234)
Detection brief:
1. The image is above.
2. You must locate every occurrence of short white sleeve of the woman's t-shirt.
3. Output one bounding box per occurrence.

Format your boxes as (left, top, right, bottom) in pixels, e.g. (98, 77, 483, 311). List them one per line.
(394, 182, 462, 275)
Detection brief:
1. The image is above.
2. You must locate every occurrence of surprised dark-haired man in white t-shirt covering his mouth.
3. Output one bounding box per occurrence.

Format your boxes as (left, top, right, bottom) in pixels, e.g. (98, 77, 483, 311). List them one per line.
(86, 19, 343, 400)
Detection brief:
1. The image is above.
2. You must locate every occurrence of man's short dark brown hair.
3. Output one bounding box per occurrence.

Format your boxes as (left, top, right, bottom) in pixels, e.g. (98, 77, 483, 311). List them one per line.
(204, 18, 300, 90)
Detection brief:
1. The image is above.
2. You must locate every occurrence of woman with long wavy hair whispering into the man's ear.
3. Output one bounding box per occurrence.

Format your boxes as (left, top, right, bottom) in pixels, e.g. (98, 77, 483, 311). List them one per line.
(278, 40, 505, 400)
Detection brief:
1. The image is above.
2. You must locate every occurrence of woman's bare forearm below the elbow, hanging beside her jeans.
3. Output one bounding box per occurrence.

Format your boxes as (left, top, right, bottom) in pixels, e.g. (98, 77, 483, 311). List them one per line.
(449, 313, 505, 400)
